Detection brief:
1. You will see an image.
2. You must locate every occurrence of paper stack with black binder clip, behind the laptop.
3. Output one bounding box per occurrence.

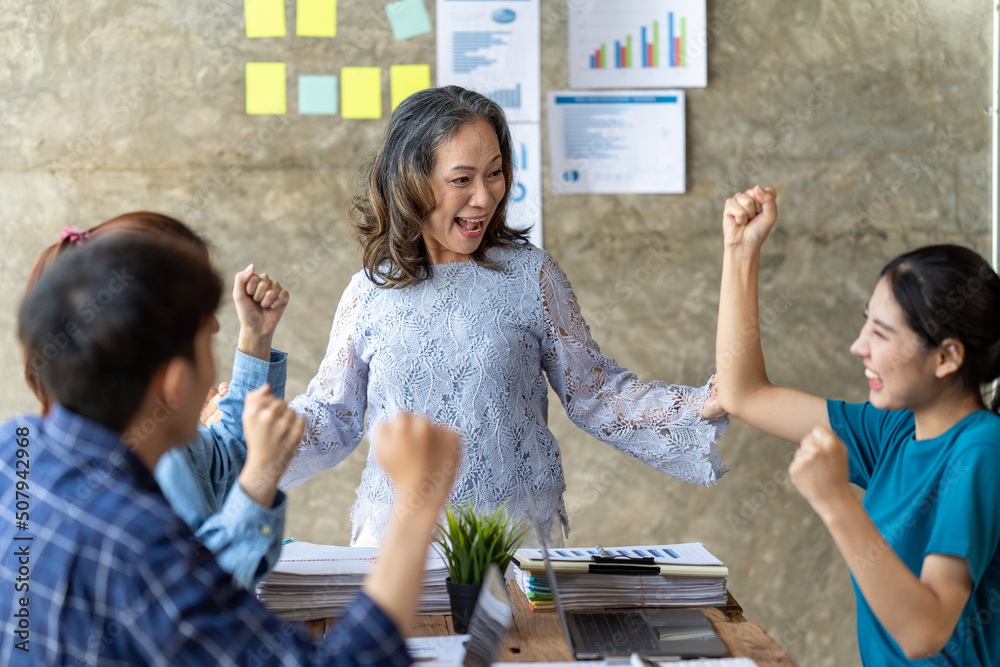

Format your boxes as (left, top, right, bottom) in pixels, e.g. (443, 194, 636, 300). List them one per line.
(514, 542, 729, 611)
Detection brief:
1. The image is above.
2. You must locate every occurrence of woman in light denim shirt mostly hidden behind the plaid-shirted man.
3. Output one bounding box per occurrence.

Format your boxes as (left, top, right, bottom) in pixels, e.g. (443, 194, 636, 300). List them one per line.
(25, 212, 288, 589)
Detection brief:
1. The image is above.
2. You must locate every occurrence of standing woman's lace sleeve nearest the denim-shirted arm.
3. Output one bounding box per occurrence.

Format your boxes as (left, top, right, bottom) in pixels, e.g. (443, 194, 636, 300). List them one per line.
(278, 279, 368, 490)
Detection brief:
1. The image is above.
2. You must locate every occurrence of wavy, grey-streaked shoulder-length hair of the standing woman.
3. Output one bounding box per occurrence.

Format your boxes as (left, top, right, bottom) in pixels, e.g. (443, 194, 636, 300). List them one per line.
(351, 86, 527, 287)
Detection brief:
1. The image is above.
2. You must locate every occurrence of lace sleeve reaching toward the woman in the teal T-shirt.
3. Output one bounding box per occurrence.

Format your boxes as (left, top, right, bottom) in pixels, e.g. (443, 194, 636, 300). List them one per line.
(539, 257, 728, 486)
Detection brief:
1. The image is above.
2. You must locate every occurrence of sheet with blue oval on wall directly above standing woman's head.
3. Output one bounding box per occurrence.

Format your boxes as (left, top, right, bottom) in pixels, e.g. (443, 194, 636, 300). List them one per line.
(436, 0, 542, 123)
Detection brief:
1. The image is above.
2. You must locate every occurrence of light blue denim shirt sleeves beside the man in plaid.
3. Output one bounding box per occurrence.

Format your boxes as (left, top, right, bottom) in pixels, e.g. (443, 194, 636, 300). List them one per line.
(155, 350, 287, 588)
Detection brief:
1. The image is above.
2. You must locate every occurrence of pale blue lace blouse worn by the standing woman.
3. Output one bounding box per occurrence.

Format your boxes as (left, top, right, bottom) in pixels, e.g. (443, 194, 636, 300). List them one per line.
(281, 245, 727, 543)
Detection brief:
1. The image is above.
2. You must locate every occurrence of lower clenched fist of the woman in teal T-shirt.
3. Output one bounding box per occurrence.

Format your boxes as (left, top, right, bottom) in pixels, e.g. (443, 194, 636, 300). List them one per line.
(788, 426, 854, 521)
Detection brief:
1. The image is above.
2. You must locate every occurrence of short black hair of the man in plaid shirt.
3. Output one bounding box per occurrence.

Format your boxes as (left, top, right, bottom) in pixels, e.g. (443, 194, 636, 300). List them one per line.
(17, 234, 222, 432)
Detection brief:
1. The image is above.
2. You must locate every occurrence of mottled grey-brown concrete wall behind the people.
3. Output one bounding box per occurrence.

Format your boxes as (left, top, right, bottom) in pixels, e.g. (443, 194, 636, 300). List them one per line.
(0, 0, 991, 667)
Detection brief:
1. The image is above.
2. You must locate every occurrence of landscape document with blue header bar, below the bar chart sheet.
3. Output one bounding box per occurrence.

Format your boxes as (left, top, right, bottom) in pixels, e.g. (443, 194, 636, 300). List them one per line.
(547, 90, 685, 194)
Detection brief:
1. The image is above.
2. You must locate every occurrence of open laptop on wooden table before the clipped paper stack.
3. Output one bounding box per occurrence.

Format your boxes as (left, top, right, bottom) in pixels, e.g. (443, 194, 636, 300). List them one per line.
(522, 488, 729, 660)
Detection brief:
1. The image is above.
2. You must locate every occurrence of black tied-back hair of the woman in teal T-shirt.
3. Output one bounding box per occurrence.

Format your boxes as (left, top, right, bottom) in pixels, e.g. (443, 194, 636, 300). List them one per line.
(881, 245, 1000, 412)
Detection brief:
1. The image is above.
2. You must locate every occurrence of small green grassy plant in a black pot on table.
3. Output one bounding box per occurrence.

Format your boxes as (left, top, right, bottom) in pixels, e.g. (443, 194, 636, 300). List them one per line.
(436, 503, 526, 634)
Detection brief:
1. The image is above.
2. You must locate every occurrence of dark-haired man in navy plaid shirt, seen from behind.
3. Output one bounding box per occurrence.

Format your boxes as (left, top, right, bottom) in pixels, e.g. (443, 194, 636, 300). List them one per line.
(0, 236, 458, 665)
